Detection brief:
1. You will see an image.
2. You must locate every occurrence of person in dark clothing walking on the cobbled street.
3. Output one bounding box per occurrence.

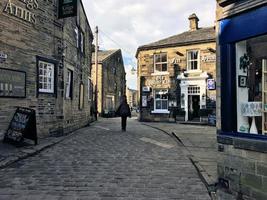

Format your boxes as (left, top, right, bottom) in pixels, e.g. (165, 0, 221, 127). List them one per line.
(116, 95, 132, 131)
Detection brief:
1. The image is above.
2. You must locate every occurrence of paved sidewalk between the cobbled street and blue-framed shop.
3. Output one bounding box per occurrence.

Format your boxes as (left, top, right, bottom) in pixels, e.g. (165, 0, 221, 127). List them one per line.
(143, 122, 218, 192)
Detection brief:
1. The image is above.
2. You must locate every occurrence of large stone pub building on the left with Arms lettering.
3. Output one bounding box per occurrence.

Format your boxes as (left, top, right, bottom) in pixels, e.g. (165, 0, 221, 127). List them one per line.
(0, 0, 93, 137)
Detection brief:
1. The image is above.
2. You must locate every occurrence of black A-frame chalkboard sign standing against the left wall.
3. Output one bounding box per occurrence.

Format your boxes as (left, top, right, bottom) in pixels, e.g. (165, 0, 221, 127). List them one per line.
(3, 107, 37, 146)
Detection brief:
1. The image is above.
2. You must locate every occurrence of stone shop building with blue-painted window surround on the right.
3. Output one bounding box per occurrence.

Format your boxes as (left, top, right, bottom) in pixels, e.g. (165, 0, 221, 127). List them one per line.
(217, 0, 267, 200)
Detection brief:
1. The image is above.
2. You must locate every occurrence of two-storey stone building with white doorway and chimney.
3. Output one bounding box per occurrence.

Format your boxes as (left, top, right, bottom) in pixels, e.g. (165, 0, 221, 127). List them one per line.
(136, 14, 216, 121)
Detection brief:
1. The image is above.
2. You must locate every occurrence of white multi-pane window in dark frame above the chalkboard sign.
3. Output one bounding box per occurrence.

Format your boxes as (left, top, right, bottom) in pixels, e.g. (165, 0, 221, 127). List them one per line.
(38, 60, 55, 94)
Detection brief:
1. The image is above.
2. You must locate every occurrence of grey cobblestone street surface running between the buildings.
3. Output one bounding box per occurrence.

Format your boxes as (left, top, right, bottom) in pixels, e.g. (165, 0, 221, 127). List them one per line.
(0, 119, 210, 200)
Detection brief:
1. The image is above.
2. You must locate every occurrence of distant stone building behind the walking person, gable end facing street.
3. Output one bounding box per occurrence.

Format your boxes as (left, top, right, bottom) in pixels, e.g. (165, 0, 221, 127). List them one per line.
(92, 49, 126, 116)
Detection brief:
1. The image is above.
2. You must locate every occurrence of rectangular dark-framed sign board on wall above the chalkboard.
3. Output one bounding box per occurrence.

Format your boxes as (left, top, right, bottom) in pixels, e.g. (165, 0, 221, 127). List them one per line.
(0, 68, 26, 98)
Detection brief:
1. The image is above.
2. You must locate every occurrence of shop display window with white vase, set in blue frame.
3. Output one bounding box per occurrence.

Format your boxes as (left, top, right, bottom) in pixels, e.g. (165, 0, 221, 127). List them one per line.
(236, 36, 267, 135)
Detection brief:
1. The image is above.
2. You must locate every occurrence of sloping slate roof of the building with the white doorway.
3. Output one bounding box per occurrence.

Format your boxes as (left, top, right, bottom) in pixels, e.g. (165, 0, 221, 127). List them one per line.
(136, 26, 216, 57)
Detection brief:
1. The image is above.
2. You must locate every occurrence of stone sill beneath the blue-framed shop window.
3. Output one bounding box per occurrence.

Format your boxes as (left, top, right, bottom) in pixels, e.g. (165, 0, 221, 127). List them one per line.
(217, 135, 267, 153)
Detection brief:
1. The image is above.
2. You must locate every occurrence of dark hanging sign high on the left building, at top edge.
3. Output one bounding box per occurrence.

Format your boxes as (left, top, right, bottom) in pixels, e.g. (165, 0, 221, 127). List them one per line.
(58, 0, 78, 19)
